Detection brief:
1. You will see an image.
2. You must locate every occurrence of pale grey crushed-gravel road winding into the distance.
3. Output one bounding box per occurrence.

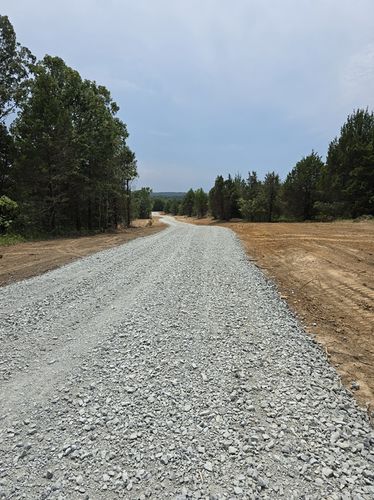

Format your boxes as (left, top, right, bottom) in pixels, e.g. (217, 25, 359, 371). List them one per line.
(0, 217, 374, 500)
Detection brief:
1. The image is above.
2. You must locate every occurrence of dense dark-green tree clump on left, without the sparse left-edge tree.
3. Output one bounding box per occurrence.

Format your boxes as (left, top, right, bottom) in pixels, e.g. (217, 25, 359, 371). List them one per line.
(12, 56, 136, 233)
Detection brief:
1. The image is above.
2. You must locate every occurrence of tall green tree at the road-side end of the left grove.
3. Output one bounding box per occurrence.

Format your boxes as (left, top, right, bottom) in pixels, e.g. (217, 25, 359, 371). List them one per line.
(69, 80, 136, 229)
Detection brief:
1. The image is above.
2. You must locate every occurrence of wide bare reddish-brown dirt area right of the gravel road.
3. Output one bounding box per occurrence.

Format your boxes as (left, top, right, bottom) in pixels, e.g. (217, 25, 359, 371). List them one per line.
(178, 217, 374, 411)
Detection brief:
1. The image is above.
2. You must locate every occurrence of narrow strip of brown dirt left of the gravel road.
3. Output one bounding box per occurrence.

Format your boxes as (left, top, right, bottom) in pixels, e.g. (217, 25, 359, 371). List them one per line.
(0, 218, 166, 286)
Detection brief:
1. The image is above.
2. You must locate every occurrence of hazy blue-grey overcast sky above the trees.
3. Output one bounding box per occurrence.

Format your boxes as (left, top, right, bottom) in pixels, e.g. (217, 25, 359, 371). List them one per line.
(0, 0, 374, 191)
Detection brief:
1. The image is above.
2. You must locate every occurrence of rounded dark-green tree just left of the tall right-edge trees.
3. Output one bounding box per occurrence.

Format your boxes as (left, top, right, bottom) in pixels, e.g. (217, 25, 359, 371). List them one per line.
(282, 151, 324, 220)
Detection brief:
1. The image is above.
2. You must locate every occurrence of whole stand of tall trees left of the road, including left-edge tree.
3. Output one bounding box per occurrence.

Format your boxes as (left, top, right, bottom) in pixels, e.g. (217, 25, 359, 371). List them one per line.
(0, 15, 137, 234)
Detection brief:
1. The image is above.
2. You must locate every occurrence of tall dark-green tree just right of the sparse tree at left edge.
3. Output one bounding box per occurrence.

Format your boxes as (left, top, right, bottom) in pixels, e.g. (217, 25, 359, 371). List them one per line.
(13, 56, 81, 231)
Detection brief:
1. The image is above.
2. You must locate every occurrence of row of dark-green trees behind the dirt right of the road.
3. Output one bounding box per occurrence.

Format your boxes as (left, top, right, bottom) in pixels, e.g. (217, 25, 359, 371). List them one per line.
(168, 109, 374, 222)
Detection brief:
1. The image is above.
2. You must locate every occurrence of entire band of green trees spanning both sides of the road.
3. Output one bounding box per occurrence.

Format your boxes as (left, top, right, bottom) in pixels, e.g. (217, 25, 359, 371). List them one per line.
(0, 15, 374, 230)
